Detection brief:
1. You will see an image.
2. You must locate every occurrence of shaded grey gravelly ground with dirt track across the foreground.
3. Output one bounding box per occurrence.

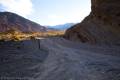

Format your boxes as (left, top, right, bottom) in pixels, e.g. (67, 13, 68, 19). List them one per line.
(0, 37, 120, 80)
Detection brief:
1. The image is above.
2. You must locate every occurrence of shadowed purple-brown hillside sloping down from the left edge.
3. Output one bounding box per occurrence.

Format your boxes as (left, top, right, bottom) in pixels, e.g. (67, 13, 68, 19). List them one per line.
(0, 12, 47, 32)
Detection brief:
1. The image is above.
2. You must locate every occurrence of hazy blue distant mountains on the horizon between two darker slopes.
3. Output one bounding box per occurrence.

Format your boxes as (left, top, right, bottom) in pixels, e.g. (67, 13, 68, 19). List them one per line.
(47, 23, 75, 30)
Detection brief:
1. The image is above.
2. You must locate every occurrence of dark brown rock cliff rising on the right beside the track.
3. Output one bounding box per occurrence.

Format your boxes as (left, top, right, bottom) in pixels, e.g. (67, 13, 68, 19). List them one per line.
(65, 0, 120, 45)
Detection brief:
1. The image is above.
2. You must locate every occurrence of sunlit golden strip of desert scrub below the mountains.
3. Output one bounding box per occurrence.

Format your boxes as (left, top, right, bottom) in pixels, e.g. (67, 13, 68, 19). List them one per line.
(0, 29, 65, 41)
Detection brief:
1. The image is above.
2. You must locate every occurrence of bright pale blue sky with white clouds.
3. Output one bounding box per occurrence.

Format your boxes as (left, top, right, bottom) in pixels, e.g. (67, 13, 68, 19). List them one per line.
(0, 0, 91, 25)
